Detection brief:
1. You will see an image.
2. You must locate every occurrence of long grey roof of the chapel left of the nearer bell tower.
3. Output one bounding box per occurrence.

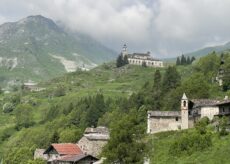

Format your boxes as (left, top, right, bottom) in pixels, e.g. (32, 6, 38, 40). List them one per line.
(148, 111, 181, 117)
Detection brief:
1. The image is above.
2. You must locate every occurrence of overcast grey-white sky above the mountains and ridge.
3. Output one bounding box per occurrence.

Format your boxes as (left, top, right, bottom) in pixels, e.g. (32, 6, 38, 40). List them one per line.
(0, 0, 230, 58)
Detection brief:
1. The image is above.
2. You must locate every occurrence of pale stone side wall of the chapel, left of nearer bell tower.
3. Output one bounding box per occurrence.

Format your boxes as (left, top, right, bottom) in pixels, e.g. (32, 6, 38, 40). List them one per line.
(147, 117, 181, 133)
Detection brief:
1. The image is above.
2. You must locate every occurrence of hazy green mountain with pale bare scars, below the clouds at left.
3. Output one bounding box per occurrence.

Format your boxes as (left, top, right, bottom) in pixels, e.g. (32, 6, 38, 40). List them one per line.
(0, 15, 117, 86)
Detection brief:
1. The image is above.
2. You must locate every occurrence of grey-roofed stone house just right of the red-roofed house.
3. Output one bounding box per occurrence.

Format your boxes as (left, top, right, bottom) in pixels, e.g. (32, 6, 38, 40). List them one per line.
(77, 127, 109, 157)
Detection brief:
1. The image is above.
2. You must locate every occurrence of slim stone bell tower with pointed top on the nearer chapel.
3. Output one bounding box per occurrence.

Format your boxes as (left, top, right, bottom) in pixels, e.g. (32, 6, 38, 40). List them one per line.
(181, 93, 188, 129)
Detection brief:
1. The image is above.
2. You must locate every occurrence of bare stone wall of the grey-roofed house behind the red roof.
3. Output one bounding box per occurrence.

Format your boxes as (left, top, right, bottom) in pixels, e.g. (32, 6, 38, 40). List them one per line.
(77, 136, 108, 157)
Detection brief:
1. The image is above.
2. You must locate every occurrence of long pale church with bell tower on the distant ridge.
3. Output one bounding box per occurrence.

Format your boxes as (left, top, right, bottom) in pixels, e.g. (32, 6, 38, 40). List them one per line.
(121, 44, 163, 67)
